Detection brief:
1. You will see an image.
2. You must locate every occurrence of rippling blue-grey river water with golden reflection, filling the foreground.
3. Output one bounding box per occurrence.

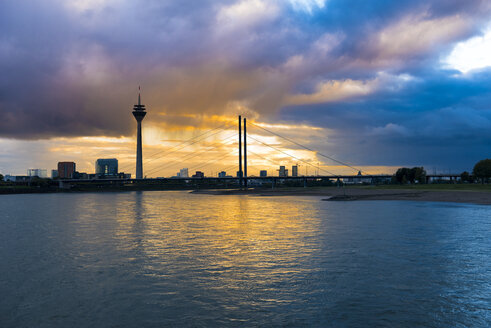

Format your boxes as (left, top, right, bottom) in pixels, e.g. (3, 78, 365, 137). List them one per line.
(0, 191, 491, 327)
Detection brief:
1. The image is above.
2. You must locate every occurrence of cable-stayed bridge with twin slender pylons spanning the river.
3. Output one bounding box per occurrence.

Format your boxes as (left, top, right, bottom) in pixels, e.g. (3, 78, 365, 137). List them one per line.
(59, 116, 460, 188)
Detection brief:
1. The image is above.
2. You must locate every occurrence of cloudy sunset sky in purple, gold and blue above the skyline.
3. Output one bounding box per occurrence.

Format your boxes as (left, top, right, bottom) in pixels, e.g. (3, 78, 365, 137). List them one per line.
(0, 0, 491, 177)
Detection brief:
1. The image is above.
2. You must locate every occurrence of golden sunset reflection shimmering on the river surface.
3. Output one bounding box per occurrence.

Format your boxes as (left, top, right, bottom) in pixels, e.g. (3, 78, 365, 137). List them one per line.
(115, 192, 319, 284)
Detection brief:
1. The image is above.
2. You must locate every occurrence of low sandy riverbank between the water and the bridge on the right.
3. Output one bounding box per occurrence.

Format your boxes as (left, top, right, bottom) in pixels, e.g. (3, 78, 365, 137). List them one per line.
(194, 188, 491, 205)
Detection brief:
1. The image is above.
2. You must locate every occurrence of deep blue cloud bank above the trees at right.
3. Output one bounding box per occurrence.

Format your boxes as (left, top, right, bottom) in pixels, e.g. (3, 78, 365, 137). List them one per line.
(283, 69, 491, 170)
